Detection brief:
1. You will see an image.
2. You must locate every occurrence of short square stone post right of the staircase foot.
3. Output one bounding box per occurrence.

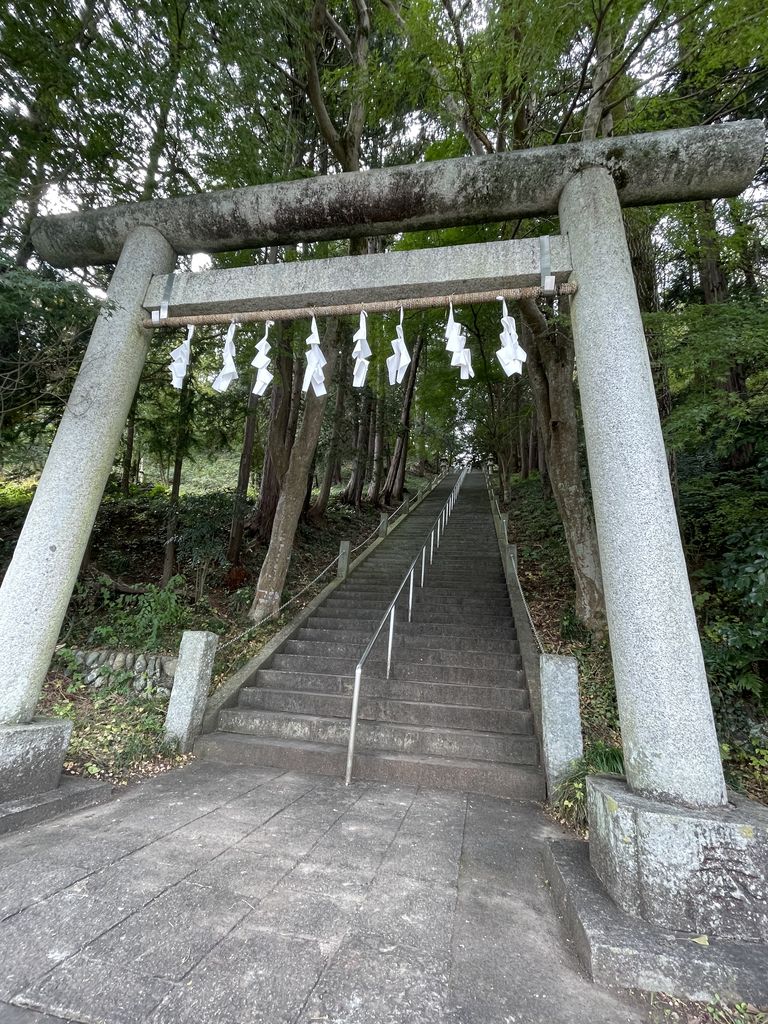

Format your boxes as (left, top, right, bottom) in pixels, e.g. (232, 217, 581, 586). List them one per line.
(539, 654, 584, 800)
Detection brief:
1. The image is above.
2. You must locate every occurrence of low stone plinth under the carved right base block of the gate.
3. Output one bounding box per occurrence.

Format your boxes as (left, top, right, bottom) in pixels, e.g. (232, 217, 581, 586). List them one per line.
(544, 840, 768, 1007)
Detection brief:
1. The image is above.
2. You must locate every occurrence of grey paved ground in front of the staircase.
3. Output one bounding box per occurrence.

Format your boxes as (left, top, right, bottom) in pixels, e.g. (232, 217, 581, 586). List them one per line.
(0, 763, 646, 1024)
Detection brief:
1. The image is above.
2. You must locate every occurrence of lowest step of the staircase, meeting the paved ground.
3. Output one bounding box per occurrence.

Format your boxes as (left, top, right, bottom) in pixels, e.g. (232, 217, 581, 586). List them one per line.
(195, 732, 545, 801)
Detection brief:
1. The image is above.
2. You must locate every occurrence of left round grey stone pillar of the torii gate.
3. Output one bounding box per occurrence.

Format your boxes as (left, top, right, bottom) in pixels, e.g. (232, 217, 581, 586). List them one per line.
(0, 227, 175, 724)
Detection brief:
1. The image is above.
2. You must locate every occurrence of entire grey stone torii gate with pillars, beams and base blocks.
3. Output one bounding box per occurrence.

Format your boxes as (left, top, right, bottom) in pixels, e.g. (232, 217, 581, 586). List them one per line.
(0, 121, 768, 995)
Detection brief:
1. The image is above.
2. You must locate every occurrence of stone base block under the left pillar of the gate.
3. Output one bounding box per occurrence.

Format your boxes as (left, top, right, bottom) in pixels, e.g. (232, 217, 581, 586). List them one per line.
(0, 718, 72, 803)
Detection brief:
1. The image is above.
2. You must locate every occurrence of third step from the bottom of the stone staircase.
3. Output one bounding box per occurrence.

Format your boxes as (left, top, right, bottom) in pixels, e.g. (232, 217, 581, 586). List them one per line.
(240, 686, 532, 735)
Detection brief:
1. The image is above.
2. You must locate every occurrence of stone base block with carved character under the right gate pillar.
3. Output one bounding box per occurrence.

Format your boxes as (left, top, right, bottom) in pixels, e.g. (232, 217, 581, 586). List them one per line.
(587, 776, 768, 943)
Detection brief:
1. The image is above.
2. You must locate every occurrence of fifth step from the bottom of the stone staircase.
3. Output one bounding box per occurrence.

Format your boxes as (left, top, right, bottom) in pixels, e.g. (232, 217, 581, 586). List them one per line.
(269, 644, 522, 686)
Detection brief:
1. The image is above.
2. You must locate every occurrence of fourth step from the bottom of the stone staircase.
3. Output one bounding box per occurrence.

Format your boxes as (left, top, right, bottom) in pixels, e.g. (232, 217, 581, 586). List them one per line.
(252, 669, 528, 711)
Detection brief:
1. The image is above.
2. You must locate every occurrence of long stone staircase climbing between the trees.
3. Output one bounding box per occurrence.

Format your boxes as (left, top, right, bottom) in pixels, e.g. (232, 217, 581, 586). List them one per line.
(195, 472, 545, 800)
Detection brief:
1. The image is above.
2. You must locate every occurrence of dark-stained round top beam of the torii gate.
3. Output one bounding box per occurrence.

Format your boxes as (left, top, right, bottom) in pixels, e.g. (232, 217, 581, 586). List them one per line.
(32, 120, 764, 266)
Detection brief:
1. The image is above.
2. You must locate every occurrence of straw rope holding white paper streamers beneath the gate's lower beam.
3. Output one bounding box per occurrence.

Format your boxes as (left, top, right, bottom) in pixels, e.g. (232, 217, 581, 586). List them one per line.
(142, 282, 577, 328)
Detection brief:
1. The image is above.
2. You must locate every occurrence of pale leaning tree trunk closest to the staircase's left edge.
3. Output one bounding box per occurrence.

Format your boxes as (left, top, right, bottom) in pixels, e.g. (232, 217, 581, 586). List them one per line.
(249, 319, 338, 623)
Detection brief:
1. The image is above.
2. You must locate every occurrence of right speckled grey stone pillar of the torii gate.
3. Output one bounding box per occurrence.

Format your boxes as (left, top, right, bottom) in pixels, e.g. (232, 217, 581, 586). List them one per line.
(560, 167, 726, 807)
